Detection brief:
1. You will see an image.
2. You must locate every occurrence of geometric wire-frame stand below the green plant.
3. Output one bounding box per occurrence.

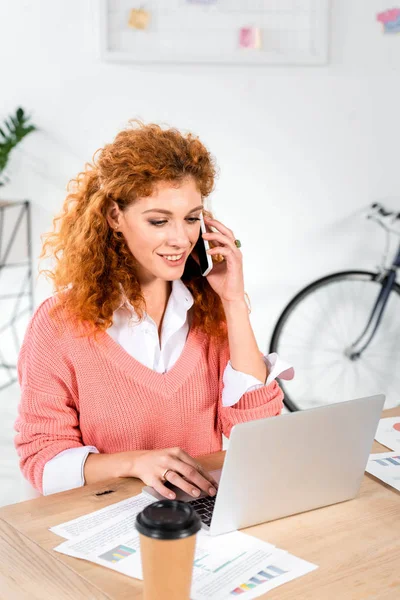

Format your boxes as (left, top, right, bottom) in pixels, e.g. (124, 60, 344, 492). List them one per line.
(0, 200, 33, 391)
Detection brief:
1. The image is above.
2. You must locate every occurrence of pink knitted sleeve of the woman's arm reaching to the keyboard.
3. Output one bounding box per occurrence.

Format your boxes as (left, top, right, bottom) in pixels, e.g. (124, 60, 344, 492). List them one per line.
(14, 299, 84, 493)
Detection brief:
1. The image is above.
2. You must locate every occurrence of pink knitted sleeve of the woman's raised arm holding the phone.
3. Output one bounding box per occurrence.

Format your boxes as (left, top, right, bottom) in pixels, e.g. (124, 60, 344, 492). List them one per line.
(216, 330, 283, 438)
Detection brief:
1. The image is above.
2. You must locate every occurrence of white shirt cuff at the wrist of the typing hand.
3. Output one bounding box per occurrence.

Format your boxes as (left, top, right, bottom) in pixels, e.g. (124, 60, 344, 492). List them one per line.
(42, 446, 100, 496)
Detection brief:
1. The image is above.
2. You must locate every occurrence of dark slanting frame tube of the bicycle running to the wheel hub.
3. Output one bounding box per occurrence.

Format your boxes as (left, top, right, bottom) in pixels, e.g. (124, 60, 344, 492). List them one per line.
(345, 244, 400, 360)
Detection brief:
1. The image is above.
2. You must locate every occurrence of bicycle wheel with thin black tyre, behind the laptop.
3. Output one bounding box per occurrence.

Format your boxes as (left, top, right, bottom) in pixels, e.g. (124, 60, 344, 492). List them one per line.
(270, 271, 400, 411)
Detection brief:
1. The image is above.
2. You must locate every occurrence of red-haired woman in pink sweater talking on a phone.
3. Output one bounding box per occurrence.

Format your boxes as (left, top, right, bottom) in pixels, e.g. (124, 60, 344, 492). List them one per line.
(15, 123, 293, 498)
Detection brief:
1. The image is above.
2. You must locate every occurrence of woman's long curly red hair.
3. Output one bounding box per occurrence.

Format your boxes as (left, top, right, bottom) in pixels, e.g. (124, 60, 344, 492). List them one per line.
(40, 120, 226, 336)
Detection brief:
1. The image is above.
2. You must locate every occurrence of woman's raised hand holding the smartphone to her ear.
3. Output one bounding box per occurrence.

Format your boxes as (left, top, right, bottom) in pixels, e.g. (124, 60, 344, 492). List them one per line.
(203, 216, 245, 303)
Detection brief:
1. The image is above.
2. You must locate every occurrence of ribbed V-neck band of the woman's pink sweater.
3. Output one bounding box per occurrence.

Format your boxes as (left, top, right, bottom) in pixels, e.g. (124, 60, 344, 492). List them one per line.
(98, 327, 205, 391)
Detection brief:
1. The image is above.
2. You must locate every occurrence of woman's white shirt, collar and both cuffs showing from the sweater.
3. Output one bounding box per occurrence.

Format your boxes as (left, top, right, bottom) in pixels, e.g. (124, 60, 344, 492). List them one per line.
(43, 279, 294, 496)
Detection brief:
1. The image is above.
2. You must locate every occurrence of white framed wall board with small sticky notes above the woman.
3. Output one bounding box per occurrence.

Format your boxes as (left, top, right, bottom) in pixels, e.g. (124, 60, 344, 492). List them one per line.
(100, 0, 331, 66)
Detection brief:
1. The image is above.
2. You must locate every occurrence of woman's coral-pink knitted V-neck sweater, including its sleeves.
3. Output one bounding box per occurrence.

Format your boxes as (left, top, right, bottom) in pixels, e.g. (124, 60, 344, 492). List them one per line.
(14, 297, 283, 493)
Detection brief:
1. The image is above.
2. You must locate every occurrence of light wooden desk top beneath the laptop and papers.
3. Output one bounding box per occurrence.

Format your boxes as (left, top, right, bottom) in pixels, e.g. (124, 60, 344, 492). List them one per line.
(0, 408, 400, 600)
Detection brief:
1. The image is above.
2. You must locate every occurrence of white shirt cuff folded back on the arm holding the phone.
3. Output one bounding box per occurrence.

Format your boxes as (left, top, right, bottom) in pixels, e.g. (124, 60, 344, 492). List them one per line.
(222, 352, 294, 406)
